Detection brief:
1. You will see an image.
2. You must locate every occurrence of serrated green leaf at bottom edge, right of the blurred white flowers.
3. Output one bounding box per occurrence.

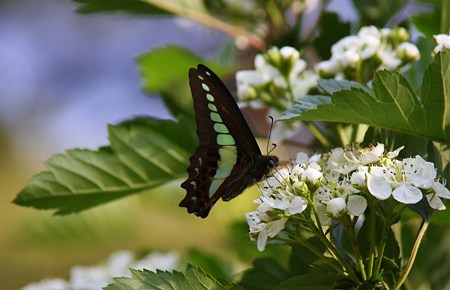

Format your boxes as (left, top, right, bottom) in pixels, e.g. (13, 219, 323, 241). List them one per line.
(105, 265, 227, 290)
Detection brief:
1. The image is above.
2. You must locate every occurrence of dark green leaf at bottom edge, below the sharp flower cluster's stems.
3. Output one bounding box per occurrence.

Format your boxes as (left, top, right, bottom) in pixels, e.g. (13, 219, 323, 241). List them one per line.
(273, 272, 342, 290)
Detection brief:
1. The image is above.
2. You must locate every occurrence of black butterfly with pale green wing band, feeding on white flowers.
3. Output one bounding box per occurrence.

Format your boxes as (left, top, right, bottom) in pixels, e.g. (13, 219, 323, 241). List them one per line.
(179, 64, 278, 218)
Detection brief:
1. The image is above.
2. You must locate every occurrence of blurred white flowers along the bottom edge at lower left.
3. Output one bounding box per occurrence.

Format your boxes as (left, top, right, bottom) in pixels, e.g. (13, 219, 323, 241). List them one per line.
(22, 250, 180, 290)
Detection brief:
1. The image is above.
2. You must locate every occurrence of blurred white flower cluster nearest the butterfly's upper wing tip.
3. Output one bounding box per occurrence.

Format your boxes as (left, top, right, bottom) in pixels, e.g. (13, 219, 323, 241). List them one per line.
(236, 46, 319, 111)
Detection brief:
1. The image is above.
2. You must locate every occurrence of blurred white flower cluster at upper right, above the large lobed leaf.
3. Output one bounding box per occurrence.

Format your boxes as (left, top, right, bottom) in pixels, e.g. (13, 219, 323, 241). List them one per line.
(316, 26, 420, 79)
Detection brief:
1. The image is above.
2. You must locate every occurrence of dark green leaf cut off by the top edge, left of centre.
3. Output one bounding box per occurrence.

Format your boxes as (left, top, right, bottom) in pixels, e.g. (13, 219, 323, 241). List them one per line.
(73, 0, 168, 14)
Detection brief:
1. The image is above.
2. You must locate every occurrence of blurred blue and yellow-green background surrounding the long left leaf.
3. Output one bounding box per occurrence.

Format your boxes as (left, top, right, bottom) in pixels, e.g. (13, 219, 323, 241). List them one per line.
(0, 0, 239, 289)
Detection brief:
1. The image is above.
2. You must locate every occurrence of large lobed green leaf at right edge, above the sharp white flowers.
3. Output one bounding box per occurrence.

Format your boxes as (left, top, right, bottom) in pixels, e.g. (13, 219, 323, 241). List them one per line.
(280, 51, 450, 143)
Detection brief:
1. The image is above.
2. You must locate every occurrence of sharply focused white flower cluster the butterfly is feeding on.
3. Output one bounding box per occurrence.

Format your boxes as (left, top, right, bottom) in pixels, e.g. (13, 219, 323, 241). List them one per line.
(247, 144, 450, 251)
